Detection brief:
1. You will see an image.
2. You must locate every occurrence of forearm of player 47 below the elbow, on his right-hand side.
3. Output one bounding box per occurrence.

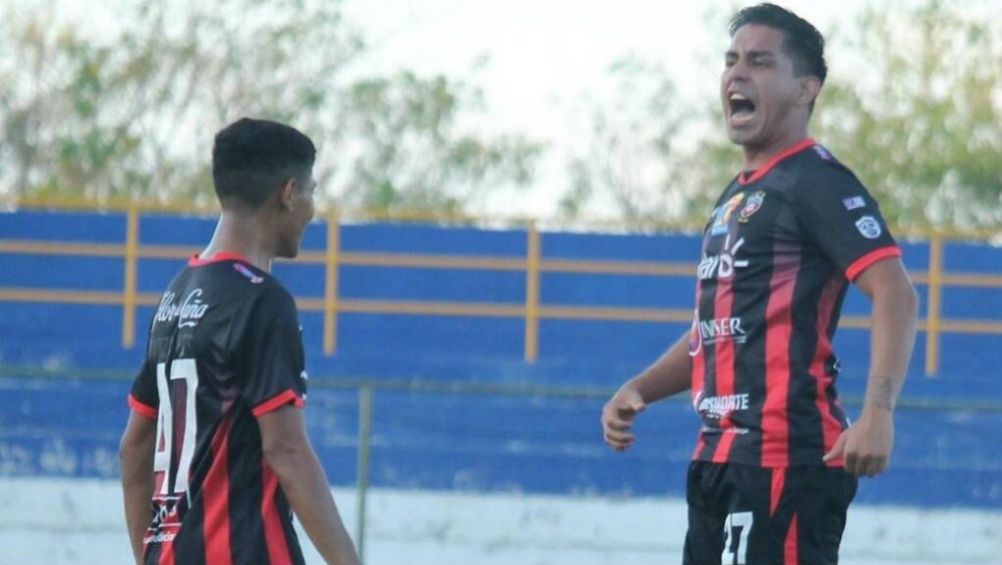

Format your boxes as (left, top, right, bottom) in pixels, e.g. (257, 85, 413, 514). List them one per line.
(267, 445, 361, 565)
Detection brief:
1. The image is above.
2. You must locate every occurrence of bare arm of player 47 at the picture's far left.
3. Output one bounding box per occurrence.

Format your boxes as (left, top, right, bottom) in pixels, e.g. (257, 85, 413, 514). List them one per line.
(118, 412, 156, 564)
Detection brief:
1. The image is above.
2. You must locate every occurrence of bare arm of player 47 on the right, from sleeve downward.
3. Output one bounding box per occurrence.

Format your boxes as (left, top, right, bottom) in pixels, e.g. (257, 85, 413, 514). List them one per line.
(258, 406, 361, 565)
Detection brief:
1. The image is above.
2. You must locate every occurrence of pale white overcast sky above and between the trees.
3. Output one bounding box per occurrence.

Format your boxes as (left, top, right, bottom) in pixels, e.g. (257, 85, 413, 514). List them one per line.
(9, 0, 1002, 216)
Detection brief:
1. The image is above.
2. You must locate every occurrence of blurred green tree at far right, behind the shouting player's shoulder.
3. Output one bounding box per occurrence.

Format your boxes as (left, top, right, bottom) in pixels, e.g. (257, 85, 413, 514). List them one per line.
(816, 0, 1002, 230)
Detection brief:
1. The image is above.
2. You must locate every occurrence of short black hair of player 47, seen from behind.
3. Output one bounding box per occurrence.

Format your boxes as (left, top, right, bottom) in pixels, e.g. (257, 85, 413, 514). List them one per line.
(212, 117, 317, 208)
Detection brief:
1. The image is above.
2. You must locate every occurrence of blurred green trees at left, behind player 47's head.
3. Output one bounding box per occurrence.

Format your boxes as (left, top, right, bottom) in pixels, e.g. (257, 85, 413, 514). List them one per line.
(0, 0, 538, 210)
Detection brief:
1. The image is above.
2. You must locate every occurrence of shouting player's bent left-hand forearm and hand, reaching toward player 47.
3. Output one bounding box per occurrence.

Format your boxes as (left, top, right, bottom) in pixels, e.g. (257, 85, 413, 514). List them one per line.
(602, 333, 692, 451)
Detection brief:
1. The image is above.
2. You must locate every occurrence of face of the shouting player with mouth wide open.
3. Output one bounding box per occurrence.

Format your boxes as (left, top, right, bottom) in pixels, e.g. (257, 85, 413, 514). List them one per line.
(720, 24, 808, 149)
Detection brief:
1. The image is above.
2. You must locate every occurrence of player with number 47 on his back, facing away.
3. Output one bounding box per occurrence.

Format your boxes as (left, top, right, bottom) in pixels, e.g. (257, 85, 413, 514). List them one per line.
(121, 118, 359, 565)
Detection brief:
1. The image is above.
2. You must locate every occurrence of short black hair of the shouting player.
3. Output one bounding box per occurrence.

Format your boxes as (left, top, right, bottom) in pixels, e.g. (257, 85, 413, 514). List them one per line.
(728, 3, 828, 83)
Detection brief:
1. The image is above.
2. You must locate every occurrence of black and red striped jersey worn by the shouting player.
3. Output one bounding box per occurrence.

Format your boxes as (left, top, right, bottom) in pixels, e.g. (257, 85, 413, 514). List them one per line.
(689, 139, 901, 467)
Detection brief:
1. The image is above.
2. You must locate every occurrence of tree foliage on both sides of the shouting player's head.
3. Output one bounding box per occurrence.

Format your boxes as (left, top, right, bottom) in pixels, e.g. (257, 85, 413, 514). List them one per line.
(566, 0, 1002, 230)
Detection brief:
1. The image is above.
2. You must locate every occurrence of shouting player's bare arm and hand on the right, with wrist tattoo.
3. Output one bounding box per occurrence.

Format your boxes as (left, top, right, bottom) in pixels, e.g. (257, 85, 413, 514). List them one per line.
(825, 258, 919, 477)
